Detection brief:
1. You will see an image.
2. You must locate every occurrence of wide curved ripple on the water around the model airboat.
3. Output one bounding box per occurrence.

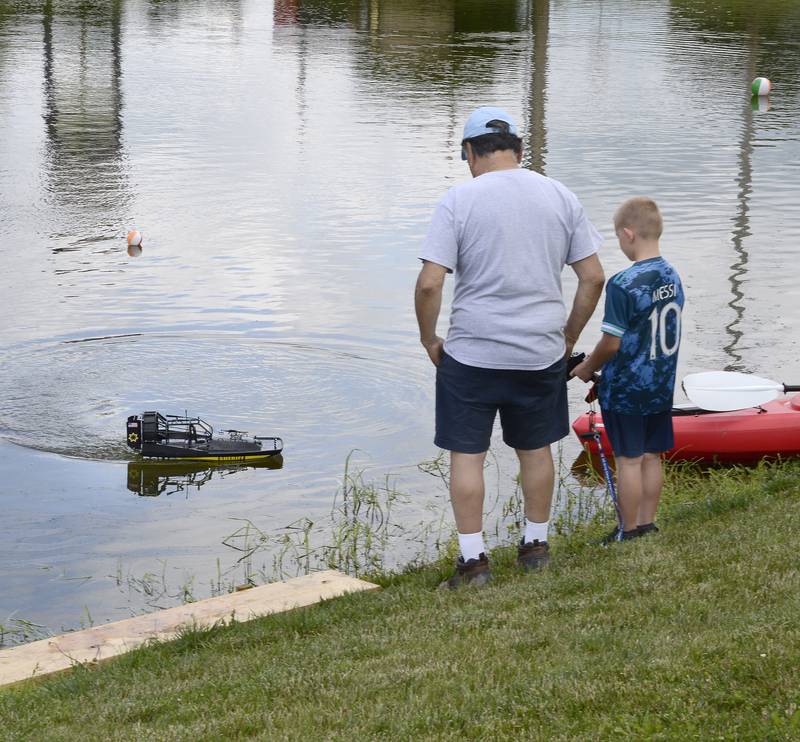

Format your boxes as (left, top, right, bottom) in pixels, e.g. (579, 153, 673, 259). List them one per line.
(0, 334, 433, 459)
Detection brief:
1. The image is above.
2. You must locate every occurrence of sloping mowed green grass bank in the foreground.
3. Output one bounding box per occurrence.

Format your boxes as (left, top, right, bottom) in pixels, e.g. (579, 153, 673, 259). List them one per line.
(0, 464, 800, 740)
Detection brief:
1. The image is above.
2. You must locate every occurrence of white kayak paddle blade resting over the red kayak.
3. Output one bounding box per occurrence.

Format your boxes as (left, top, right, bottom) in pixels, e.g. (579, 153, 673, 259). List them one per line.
(682, 371, 800, 412)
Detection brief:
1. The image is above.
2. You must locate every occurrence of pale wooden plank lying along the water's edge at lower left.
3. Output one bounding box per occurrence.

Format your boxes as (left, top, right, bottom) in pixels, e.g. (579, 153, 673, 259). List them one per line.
(0, 570, 379, 686)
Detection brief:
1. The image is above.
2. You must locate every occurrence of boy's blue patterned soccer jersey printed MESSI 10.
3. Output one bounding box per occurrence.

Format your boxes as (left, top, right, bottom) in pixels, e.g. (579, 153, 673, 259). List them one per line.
(598, 257, 684, 415)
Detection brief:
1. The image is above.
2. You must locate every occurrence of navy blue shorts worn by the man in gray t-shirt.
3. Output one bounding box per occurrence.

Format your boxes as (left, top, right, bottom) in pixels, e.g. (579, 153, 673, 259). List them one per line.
(434, 353, 569, 453)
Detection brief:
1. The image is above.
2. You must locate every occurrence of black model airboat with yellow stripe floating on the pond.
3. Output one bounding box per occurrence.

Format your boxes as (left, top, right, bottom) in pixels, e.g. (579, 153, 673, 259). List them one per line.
(127, 412, 283, 463)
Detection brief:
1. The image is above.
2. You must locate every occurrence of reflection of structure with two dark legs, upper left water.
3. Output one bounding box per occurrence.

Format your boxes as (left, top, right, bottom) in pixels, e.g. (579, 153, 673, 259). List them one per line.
(42, 0, 131, 252)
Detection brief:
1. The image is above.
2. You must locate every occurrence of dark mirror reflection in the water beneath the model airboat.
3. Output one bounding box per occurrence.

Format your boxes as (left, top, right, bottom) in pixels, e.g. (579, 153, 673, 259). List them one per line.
(128, 455, 283, 497)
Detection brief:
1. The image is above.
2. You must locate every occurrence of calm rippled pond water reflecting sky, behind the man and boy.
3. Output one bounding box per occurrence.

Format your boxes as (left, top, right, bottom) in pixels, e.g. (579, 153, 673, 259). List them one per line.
(0, 0, 800, 640)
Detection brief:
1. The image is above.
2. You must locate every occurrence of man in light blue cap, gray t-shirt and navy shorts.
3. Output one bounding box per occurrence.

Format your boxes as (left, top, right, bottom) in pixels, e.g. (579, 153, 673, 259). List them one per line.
(415, 107, 604, 588)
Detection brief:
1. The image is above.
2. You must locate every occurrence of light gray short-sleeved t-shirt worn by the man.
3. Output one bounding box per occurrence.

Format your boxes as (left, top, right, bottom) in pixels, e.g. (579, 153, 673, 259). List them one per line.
(420, 168, 603, 370)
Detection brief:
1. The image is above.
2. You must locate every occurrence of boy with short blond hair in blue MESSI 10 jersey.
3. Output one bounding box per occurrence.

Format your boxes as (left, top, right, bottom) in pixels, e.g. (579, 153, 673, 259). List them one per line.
(573, 197, 684, 543)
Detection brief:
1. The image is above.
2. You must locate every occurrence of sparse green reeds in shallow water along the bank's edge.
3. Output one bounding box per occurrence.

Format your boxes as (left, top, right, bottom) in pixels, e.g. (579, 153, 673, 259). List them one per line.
(0, 447, 607, 650)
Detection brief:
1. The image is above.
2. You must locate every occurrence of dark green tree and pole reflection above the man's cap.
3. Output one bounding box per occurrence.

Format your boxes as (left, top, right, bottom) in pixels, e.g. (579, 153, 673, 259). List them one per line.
(273, 0, 550, 171)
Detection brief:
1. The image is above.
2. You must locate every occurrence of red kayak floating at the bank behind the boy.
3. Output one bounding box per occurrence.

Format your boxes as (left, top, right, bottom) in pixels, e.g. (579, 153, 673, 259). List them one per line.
(572, 394, 800, 463)
